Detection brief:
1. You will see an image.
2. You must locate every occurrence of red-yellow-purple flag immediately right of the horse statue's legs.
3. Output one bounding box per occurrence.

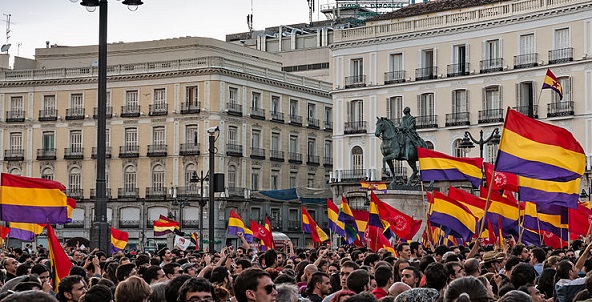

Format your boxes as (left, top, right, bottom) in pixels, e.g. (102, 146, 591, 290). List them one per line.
(417, 148, 483, 188)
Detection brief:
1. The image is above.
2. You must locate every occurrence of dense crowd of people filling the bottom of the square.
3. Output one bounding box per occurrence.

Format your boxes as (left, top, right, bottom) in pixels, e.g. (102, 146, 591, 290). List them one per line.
(0, 230, 592, 302)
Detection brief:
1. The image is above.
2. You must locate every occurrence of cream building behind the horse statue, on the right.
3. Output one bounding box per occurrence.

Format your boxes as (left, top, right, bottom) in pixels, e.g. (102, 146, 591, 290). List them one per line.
(330, 0, 592, 203)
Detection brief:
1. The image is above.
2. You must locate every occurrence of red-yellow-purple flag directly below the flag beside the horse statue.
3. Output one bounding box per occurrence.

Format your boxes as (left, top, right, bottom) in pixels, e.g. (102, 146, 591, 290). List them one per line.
(429, 191, 477, 240)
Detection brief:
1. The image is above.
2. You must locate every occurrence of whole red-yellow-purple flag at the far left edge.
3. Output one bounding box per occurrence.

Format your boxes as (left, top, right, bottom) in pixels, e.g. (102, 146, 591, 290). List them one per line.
(0, 173, 69, 224)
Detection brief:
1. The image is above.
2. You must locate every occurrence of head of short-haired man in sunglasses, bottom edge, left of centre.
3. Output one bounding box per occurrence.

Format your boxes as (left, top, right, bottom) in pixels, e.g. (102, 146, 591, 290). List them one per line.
(234, 268, 277, 302)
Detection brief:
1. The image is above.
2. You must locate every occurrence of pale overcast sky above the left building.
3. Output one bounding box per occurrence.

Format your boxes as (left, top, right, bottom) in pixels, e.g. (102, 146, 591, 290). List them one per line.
(0, 0, 334, 58)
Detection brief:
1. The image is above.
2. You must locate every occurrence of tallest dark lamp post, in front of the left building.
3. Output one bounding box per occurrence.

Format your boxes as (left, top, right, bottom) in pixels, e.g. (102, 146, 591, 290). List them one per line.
(71, 0, 144, 251)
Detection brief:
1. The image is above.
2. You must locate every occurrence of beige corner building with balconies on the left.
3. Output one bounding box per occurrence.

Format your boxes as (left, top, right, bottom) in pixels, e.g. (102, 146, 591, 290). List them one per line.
(0, 38, 333, 247)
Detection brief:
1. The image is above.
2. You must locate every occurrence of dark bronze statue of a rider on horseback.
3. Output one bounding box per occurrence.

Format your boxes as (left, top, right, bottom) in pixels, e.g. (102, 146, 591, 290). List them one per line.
(374, 107, 427, 187)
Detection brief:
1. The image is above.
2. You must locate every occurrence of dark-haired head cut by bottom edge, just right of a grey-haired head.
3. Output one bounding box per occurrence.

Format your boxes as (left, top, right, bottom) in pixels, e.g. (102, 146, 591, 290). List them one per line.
(444, 277, 490, 302)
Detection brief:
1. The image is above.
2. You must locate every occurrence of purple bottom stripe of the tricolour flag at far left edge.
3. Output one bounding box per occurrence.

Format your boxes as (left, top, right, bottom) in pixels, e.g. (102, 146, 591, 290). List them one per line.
(1, 204, 68, 224)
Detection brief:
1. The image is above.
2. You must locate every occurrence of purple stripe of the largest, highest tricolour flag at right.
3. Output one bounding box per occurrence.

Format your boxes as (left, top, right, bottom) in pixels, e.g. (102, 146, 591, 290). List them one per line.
(495, 150, 580, 181)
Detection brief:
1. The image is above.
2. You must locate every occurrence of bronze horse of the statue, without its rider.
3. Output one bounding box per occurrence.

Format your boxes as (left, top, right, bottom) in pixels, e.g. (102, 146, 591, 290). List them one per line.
(374, 117, 427, 186)
